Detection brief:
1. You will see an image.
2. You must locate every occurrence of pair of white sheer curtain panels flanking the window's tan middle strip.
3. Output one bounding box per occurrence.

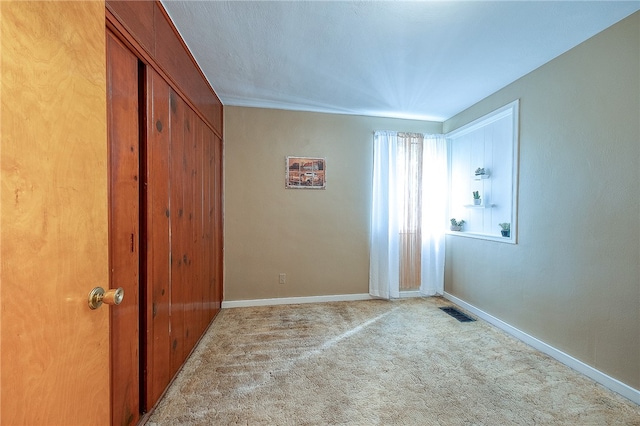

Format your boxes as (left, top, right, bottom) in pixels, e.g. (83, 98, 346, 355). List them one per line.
(369, 131, 448, 299)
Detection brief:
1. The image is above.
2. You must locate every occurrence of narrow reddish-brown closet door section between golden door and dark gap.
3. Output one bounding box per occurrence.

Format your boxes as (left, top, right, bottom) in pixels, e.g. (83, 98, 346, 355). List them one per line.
(107, 31, 142, 425)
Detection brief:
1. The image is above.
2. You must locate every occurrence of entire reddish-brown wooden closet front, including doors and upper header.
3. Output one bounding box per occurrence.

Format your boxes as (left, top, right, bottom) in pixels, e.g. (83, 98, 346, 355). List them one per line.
(106, 0, 222, 416)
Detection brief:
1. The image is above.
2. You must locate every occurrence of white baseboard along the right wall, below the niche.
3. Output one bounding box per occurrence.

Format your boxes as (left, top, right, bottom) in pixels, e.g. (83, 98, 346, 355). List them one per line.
(444, 292, 640, 405)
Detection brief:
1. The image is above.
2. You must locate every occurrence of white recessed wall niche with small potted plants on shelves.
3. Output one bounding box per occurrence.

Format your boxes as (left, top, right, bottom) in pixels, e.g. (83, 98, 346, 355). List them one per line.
(447, 100, 519, 244)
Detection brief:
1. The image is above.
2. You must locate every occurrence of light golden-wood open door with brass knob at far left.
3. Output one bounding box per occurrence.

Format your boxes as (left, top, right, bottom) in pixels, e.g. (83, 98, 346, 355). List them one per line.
(0, 1, 109, 425)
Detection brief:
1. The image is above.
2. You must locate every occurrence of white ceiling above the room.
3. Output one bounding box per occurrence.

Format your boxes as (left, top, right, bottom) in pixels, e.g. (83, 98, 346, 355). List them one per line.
(162, 0, 640, 121)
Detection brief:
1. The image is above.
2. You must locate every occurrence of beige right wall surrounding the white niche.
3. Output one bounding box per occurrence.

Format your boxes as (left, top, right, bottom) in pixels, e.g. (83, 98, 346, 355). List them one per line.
(444, 13, 640, 389)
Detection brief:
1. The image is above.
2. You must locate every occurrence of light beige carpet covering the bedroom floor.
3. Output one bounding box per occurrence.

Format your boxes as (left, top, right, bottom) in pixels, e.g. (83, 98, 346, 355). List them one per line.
(147, 298, 640, 426)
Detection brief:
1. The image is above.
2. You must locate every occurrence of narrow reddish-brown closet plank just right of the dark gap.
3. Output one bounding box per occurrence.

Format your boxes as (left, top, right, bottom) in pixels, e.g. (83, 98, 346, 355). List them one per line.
(144, 68, 173, 409)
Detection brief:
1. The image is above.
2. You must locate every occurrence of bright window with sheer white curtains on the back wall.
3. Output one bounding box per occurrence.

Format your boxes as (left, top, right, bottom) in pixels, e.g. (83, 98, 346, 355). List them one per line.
(369, 131, 447, 299)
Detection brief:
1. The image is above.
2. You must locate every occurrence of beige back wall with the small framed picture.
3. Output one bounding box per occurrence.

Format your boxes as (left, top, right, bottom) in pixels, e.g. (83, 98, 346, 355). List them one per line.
(224, 107, 442, 301)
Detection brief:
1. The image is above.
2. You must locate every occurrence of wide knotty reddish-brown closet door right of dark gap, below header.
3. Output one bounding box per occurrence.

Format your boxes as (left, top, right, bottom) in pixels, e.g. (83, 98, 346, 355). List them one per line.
(145, 70, 221, 407)
